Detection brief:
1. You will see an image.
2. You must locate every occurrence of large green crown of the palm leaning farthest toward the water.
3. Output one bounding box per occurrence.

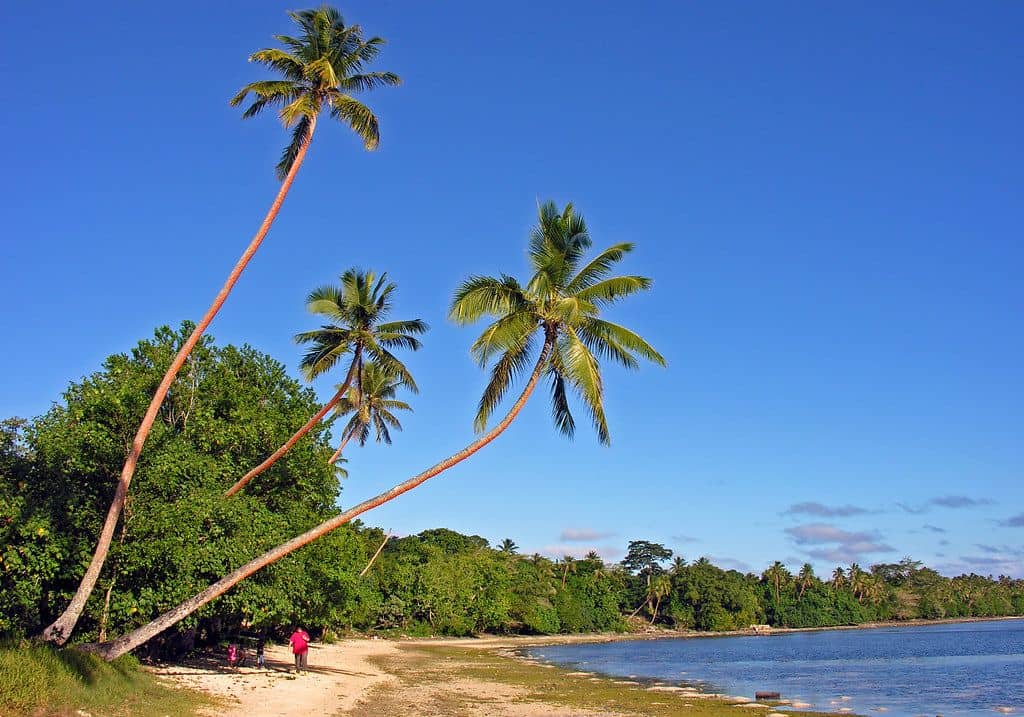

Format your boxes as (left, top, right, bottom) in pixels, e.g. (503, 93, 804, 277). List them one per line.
(451, 202, 666, 444)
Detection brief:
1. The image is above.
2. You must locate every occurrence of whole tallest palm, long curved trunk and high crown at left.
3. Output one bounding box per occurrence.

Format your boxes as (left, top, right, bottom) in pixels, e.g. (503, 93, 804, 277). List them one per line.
(42, 5, 400, 644)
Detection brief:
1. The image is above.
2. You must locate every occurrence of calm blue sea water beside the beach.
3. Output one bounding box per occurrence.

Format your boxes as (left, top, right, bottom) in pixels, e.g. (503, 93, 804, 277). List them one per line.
(529, 620, 1024, 717)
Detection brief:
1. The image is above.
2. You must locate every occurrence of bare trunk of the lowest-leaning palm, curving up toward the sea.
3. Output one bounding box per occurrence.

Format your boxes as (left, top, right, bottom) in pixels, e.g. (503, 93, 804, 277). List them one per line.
(92, 340, 552, 661)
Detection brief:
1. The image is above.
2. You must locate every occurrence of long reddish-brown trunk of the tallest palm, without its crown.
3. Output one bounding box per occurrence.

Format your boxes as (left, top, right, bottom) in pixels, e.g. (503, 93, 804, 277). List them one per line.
(42, 117, 316, 645)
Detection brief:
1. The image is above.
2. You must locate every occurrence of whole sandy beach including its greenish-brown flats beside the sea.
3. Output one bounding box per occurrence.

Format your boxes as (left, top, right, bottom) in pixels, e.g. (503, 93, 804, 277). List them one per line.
(153, 635, 798, 717)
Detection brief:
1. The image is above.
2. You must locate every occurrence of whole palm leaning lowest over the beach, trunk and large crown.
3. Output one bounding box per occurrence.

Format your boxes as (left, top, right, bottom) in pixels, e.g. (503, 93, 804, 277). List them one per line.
(95, 202, 666, 660)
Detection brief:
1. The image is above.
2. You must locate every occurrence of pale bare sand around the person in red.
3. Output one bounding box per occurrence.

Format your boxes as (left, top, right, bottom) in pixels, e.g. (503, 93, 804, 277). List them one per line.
(154, 640, 397, 717)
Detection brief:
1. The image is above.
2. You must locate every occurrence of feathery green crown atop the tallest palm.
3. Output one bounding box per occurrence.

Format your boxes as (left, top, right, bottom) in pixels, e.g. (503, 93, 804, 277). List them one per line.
(230, 5, 401, 179)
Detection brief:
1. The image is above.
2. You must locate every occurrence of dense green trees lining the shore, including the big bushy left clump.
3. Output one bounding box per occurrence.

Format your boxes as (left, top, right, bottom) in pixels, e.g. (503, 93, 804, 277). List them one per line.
(0, 327, 1024, 653)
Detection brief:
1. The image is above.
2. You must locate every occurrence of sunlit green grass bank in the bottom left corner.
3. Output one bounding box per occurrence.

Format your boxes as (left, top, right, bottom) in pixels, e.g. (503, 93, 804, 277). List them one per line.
(0, 643, 213, 717)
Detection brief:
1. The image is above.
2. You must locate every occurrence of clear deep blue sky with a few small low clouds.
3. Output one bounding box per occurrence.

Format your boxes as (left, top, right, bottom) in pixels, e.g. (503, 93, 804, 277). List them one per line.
(0, 0, 1024, 577)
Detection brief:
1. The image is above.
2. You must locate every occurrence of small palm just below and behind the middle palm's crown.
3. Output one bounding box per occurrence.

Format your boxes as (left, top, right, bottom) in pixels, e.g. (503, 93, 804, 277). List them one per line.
(328, 362, 413, 463)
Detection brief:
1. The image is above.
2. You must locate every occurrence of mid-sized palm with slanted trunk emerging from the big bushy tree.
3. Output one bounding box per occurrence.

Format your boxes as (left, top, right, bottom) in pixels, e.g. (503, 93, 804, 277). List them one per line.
(224, 268, 427, 496)
